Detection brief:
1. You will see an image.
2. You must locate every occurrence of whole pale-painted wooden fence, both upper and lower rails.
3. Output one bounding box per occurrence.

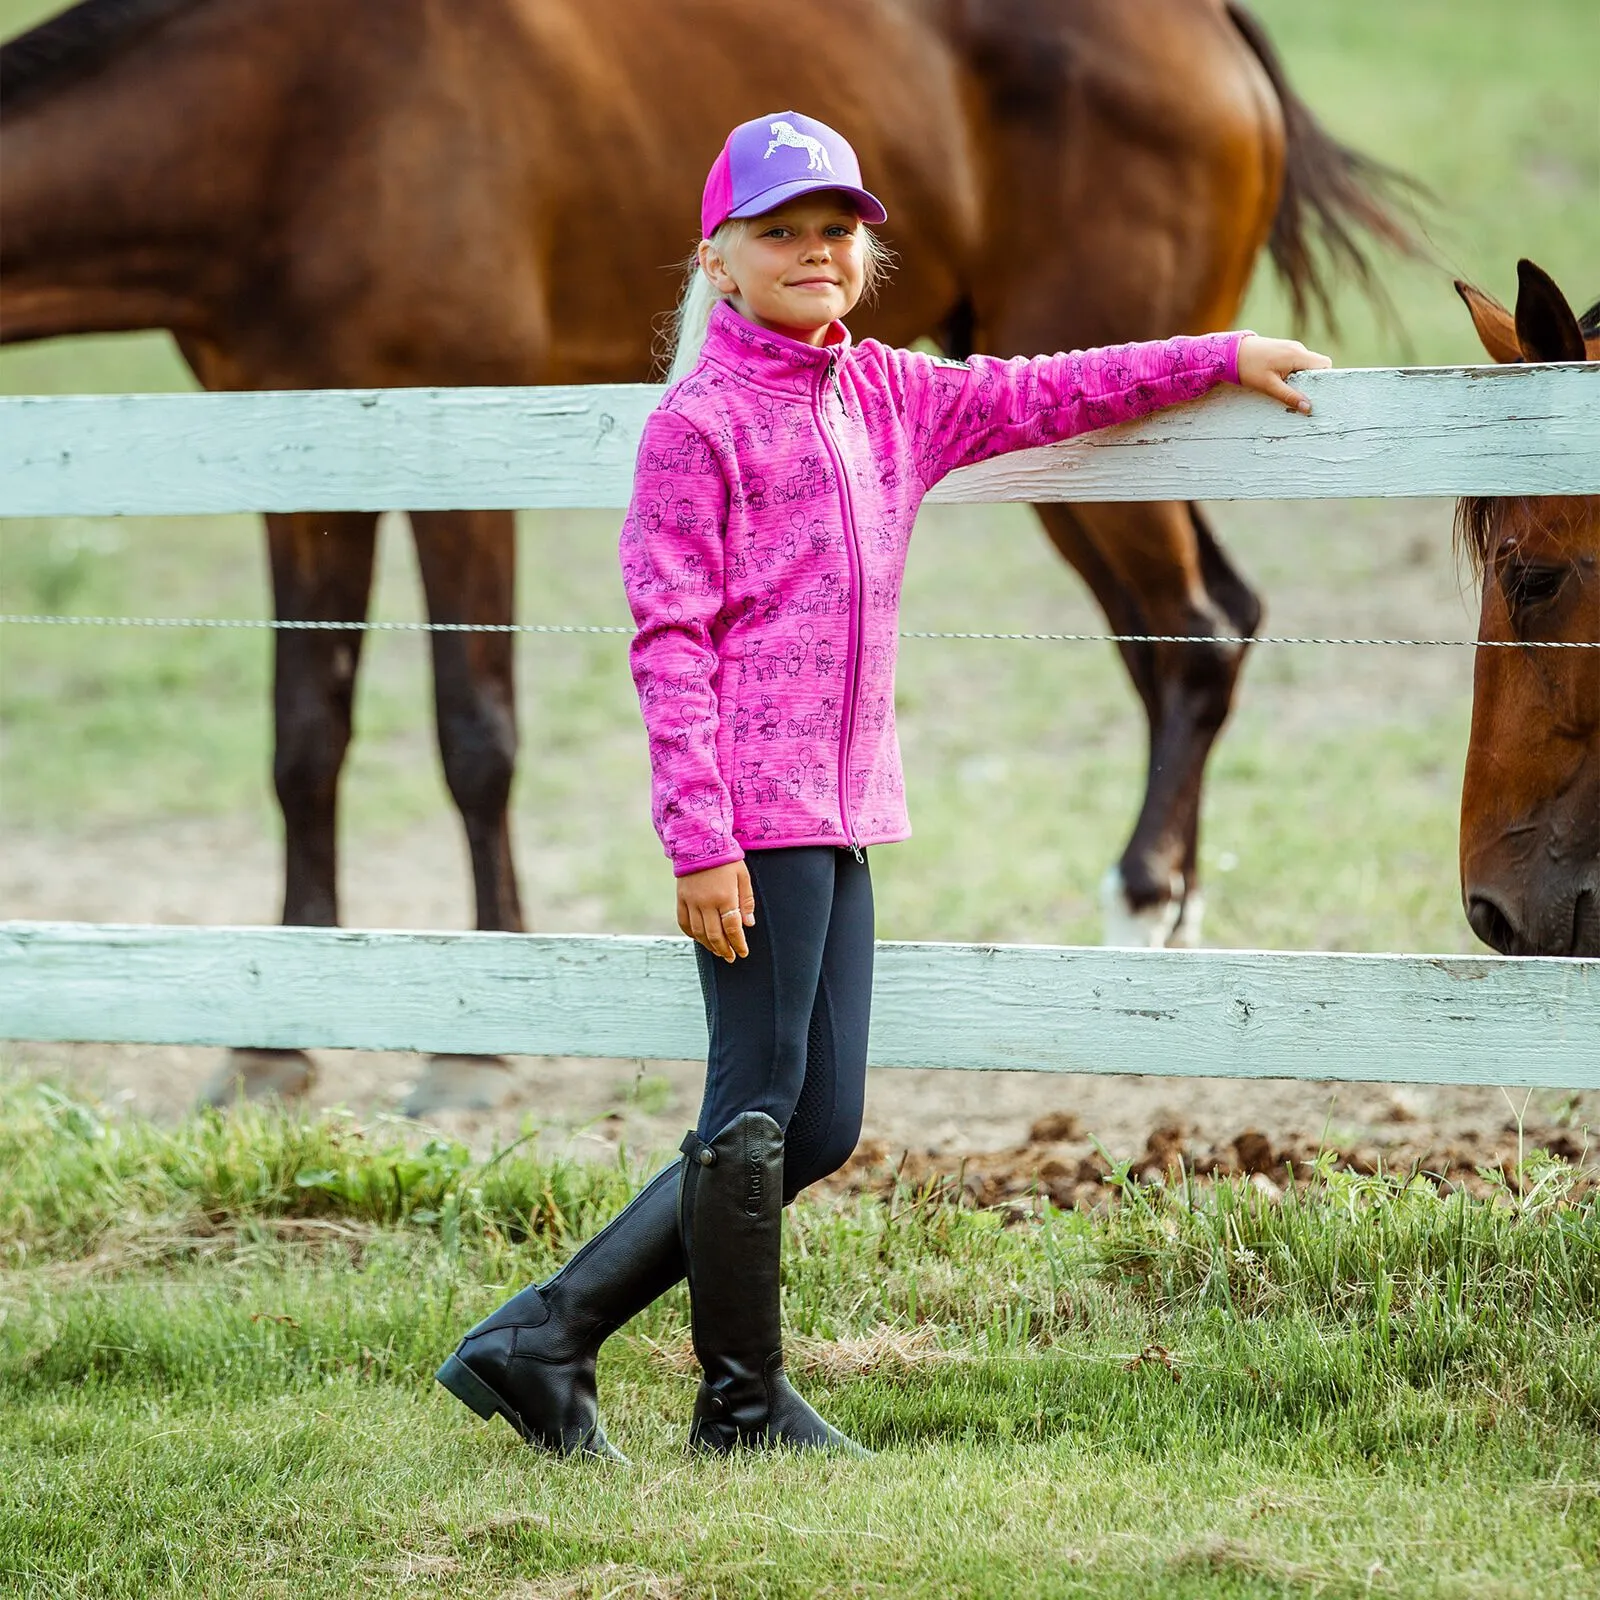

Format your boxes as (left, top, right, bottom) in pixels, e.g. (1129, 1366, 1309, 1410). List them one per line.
(0, 363, 1600, 1088)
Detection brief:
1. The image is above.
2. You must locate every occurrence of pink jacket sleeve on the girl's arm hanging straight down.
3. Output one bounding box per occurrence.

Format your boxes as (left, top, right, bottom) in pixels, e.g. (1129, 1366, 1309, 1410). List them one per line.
(621, 411, 744, 877)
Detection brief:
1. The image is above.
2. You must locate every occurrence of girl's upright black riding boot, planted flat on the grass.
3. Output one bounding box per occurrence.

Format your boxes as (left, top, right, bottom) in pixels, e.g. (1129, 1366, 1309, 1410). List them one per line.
(678, 1112, 869, 1456)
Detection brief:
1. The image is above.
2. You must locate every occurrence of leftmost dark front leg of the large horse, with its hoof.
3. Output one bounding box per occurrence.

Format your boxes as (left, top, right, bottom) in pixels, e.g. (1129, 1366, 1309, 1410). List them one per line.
(202, 512, 378, 1106)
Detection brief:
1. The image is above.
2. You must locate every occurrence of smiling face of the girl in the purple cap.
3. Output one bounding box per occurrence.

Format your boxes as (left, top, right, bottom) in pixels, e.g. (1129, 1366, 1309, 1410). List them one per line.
(699, 190, 866, 344)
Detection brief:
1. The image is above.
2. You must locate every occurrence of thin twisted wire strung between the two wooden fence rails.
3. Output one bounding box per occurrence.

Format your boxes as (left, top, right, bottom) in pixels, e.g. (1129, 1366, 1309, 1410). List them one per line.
(0, 613, 1600, 650)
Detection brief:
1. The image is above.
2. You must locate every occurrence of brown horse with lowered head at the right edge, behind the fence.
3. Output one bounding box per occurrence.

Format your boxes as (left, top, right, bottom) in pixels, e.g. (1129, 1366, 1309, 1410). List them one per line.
(1456, 261, 1600, 957)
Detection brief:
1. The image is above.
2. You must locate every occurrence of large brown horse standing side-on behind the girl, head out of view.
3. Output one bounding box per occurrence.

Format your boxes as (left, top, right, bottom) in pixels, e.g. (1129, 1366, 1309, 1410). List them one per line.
(0, 0, 1408, 1107)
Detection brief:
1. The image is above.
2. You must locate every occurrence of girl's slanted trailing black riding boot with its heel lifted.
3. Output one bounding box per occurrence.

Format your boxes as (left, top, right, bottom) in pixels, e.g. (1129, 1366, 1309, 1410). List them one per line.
(435, 1166, 683, 1461)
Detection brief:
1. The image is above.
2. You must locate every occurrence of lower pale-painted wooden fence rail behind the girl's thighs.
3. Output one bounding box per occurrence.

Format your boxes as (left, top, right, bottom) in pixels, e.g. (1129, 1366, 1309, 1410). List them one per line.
(0, 922, 1600, 1088)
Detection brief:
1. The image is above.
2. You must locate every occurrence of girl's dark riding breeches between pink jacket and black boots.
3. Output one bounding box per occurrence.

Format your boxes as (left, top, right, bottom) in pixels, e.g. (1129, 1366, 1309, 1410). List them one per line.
(696, 845, 872, 1202)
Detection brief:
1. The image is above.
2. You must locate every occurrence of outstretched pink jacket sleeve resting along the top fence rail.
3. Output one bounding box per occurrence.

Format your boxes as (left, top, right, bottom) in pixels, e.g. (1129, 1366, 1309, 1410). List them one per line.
(893, 333, 1246, 488)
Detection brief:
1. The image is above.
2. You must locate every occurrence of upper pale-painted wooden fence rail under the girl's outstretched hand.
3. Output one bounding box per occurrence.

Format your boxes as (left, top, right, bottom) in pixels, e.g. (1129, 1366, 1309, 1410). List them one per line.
(0, 362, 1600, 517)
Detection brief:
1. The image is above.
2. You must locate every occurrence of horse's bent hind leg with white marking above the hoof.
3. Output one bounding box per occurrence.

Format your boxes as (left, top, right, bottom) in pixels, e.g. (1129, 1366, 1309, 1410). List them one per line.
(1037, 502, 1261, 946)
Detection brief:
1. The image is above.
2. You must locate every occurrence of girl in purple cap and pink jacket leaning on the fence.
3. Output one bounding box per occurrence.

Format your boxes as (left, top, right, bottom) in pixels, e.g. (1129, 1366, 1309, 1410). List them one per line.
(438, 112, 1330, 1456)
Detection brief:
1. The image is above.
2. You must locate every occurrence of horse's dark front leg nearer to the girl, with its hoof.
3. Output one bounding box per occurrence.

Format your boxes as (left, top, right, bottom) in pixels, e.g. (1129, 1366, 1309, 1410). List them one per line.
(405, 510, 522, 1117)
